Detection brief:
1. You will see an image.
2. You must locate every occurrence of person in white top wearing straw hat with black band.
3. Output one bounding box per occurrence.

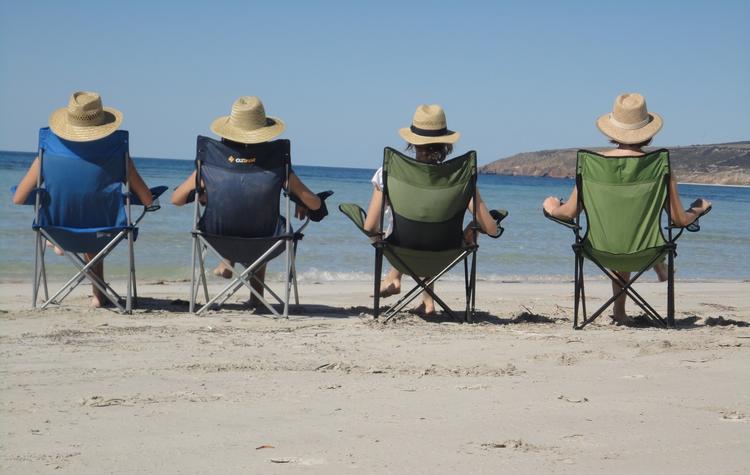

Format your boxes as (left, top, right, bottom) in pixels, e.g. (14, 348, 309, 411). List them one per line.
(364, 105, 497, 315)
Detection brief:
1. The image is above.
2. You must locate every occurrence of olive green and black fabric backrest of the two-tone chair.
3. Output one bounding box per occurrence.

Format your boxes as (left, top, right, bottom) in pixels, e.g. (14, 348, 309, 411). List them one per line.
(383, 147, 477, 251)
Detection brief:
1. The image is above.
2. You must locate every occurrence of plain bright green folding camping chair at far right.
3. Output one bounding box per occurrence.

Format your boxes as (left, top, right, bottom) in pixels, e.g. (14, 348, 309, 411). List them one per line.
(544, 149, 710, 329)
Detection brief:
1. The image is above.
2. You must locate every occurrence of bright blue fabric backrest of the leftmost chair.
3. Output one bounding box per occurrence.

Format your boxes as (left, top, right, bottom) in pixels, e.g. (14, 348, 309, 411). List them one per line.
(37, 127, 128, 228)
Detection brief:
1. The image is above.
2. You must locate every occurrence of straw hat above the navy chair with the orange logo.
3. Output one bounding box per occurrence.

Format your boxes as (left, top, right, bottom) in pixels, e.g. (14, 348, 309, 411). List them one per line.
(211, 96, 284, 143)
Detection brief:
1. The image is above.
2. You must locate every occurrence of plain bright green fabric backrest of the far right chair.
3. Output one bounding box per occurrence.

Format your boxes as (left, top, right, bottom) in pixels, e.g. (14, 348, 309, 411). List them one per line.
(576, 149, 670, 255)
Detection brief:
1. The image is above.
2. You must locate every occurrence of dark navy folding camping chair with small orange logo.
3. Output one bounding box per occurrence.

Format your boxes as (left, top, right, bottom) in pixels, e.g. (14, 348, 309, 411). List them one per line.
(190, 136, 330, 318)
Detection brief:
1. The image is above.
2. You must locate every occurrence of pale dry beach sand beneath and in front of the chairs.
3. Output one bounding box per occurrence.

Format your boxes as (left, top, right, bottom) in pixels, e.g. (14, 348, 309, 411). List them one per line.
(0, 282, 750, 474)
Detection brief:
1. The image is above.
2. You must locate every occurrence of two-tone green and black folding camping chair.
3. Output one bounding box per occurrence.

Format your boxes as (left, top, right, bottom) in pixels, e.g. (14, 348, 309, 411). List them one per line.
(339, 147, 507, 321)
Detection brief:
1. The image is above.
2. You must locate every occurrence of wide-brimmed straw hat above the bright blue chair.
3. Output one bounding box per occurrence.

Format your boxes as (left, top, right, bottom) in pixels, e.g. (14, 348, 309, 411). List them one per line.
(49, 91, 122, 142)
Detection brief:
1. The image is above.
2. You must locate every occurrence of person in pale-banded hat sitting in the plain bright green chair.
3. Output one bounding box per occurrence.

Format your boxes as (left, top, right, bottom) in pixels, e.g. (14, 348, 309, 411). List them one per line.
(542, 93, 711, 324)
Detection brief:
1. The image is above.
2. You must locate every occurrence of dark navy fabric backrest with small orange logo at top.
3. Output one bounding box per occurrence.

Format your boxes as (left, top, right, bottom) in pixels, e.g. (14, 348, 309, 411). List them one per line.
(196, 136, 291, 237)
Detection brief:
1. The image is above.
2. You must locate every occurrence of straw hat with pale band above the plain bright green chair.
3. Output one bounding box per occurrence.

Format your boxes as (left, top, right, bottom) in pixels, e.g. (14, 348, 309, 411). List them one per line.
(596, 92, 662, 144)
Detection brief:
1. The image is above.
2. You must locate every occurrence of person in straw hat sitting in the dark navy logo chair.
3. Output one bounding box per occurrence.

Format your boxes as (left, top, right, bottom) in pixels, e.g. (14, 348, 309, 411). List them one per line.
(172, 96, 328, 307)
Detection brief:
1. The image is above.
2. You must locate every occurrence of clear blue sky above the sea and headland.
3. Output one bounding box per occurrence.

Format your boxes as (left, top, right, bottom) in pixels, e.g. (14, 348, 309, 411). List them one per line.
(0, 0, 750, 167)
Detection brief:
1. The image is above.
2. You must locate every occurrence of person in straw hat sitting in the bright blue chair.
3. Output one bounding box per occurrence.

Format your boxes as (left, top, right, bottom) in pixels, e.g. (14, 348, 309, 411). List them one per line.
(13, 91, 153, 307)
